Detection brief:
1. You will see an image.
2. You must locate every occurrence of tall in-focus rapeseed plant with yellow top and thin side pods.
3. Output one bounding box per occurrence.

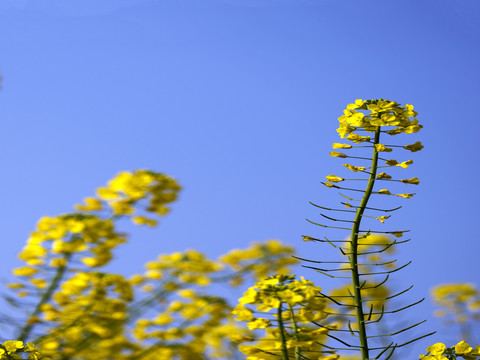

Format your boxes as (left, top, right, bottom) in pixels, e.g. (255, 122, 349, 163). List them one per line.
(304, 99, 430, 360)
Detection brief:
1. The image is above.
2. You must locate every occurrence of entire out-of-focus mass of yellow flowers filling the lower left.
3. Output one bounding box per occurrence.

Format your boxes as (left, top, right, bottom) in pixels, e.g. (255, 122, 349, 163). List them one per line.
(0, 170, 304, 360)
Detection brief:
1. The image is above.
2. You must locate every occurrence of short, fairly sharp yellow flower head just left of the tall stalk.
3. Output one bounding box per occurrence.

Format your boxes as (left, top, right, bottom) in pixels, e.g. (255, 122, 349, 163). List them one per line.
(233, 275, 327, 360)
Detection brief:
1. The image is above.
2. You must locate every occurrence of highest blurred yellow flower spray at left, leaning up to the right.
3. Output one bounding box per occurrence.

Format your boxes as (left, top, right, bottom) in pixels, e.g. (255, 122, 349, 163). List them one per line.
(9, 170, 180, 296)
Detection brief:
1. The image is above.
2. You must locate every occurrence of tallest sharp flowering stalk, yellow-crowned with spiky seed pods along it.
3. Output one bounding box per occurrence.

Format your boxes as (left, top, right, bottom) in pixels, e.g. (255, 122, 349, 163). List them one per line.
(303, 99, 427, 360)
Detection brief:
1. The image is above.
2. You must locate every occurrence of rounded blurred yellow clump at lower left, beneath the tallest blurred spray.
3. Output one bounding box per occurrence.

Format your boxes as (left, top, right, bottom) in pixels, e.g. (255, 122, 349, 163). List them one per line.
(32, 271, 133, 359)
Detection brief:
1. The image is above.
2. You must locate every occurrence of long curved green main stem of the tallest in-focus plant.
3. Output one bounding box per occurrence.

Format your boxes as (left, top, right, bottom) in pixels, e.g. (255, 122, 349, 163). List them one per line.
(349, 126, 380, 360)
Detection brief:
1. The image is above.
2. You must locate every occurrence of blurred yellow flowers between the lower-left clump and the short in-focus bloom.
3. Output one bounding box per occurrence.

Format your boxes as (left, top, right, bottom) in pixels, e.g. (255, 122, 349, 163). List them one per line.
(119, 240, 297, 360)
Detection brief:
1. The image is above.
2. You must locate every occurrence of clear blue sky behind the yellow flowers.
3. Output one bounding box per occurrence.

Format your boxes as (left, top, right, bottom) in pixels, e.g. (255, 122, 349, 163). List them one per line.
(0, 0, 480, 356)
